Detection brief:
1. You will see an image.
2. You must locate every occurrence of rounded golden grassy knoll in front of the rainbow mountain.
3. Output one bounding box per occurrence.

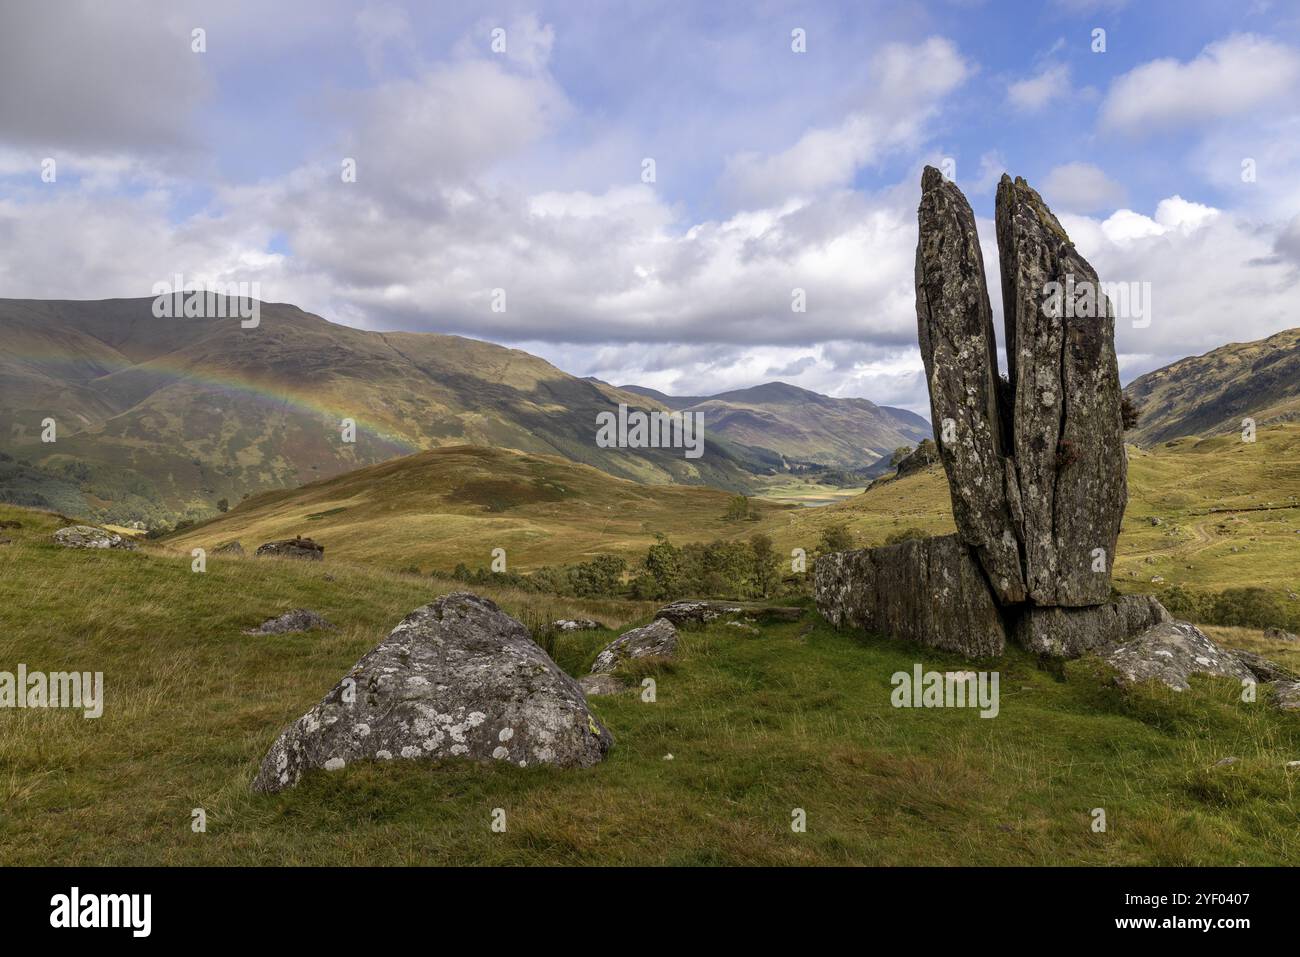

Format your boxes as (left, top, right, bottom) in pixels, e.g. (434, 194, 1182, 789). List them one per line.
(166, 446, 785, 572)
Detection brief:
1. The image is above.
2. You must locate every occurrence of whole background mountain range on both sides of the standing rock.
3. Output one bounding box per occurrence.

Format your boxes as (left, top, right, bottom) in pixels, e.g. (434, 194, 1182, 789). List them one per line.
(0, 298, 1300, 524)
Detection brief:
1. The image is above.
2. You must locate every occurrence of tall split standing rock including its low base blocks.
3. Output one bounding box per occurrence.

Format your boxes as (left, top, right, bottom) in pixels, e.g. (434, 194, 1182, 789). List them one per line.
(815, 166, 1169, 657)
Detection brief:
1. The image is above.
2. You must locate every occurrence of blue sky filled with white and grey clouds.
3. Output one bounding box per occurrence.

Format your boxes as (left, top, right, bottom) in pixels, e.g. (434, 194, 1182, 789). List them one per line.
(0, 0, 1300, 413)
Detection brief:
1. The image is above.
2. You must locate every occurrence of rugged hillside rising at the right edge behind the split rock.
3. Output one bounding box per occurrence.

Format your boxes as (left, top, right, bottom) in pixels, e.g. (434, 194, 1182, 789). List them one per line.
(1125, 329, 1300, 446)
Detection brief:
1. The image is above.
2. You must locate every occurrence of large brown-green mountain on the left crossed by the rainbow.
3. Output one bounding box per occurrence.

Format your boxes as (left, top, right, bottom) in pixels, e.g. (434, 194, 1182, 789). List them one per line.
(0, 299, 768, 521)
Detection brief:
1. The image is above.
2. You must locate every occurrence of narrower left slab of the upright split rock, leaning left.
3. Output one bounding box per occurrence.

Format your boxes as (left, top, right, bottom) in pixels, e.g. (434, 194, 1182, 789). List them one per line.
(915, 166, 1026, 605)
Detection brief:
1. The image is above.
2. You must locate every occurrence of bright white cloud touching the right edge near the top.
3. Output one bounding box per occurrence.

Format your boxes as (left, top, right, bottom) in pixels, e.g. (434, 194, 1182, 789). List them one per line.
(1101, 34, 1300, 133)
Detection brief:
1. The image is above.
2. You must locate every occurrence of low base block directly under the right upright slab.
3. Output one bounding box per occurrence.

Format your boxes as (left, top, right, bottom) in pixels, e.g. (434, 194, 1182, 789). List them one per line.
(1015, 594, 1174, 658)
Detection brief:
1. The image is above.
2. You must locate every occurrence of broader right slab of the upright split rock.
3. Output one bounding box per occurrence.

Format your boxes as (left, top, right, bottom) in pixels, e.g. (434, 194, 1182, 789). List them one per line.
(997, 176, 1127, 605)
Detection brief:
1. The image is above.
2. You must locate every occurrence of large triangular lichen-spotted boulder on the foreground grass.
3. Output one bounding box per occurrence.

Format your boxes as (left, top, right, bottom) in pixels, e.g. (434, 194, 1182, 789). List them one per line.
(252, 592, 614, 792)
